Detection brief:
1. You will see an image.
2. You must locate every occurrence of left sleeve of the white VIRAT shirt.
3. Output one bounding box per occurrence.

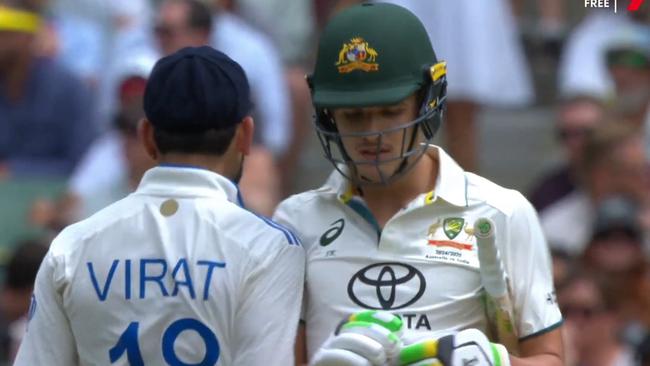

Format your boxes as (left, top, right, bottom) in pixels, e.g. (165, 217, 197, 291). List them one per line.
(14, 251, 78, 366)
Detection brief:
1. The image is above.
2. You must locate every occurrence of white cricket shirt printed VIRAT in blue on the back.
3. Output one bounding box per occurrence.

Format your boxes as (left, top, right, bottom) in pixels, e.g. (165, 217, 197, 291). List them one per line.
(16, 167, 305, 366)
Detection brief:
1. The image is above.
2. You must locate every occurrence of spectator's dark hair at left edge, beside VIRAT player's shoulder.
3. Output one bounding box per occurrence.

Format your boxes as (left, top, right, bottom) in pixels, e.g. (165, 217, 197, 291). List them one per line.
(5, 240, 47, 290)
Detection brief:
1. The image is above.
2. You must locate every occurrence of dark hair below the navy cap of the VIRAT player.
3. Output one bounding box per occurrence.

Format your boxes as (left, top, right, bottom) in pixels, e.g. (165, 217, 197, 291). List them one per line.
(154, 125, 238, 156)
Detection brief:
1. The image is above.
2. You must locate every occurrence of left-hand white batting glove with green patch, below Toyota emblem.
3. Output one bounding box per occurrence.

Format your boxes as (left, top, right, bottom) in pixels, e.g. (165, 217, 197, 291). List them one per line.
(310, 311, 402, 366)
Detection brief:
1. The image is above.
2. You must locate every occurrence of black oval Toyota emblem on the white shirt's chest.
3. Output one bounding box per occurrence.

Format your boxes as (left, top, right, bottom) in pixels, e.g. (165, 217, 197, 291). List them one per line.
(348, 262, 427, 310)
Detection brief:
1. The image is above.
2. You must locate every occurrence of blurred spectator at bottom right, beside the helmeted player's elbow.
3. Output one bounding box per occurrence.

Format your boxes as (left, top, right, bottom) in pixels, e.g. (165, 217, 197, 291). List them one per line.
(558, 273, 634, 366)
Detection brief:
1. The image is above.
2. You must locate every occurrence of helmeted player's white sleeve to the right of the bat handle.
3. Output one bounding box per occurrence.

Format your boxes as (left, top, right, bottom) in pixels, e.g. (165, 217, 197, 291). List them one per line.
(504, 193, 562, 339)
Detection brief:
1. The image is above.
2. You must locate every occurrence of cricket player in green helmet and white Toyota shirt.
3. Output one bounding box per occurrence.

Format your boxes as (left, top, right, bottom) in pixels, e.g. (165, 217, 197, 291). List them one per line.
(274, 3, 563, 366)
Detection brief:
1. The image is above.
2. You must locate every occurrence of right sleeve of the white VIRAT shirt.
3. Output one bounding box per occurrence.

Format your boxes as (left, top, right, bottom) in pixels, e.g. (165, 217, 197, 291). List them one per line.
(233, 236, 304, 366)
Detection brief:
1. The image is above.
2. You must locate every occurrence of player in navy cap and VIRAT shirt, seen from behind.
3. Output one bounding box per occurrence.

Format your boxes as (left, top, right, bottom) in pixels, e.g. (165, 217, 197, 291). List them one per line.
(16, 47, 304, 366)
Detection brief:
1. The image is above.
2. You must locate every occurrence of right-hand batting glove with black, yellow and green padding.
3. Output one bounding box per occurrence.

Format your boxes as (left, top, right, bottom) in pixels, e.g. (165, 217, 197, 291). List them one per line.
(399, 329, 510, 366)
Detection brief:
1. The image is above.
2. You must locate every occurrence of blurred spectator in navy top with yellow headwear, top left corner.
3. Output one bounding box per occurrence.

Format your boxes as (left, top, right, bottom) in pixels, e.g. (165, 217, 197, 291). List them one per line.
(0, 0, 97, 177)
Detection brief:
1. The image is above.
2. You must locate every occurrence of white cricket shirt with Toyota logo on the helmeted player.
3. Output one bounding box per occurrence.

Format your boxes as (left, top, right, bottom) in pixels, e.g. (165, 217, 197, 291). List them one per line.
(275, 149, 562, 358)
